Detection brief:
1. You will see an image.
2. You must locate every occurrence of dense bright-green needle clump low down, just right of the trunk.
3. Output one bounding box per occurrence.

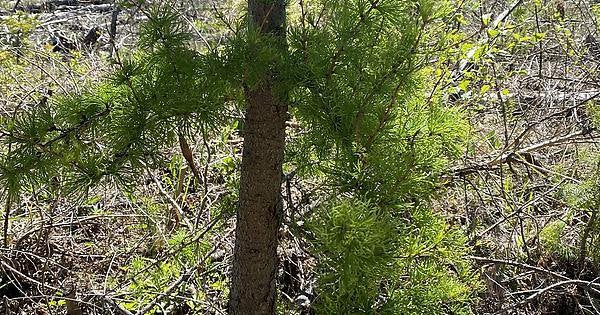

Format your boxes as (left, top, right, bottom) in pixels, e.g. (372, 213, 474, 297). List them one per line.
(310, 200, 398, 314)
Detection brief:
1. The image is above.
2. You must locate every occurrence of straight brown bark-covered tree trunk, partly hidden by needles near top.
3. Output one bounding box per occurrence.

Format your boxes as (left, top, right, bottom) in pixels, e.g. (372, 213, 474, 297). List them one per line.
(229, 0, 288, 315)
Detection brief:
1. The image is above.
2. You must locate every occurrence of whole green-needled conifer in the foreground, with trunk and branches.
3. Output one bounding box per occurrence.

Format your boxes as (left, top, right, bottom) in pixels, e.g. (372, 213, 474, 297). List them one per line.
(0, 0, 478, 314)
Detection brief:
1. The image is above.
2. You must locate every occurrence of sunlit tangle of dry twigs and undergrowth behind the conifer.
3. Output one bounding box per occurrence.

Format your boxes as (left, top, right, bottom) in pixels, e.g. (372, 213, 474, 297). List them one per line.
(0, 0, 600, 314)
